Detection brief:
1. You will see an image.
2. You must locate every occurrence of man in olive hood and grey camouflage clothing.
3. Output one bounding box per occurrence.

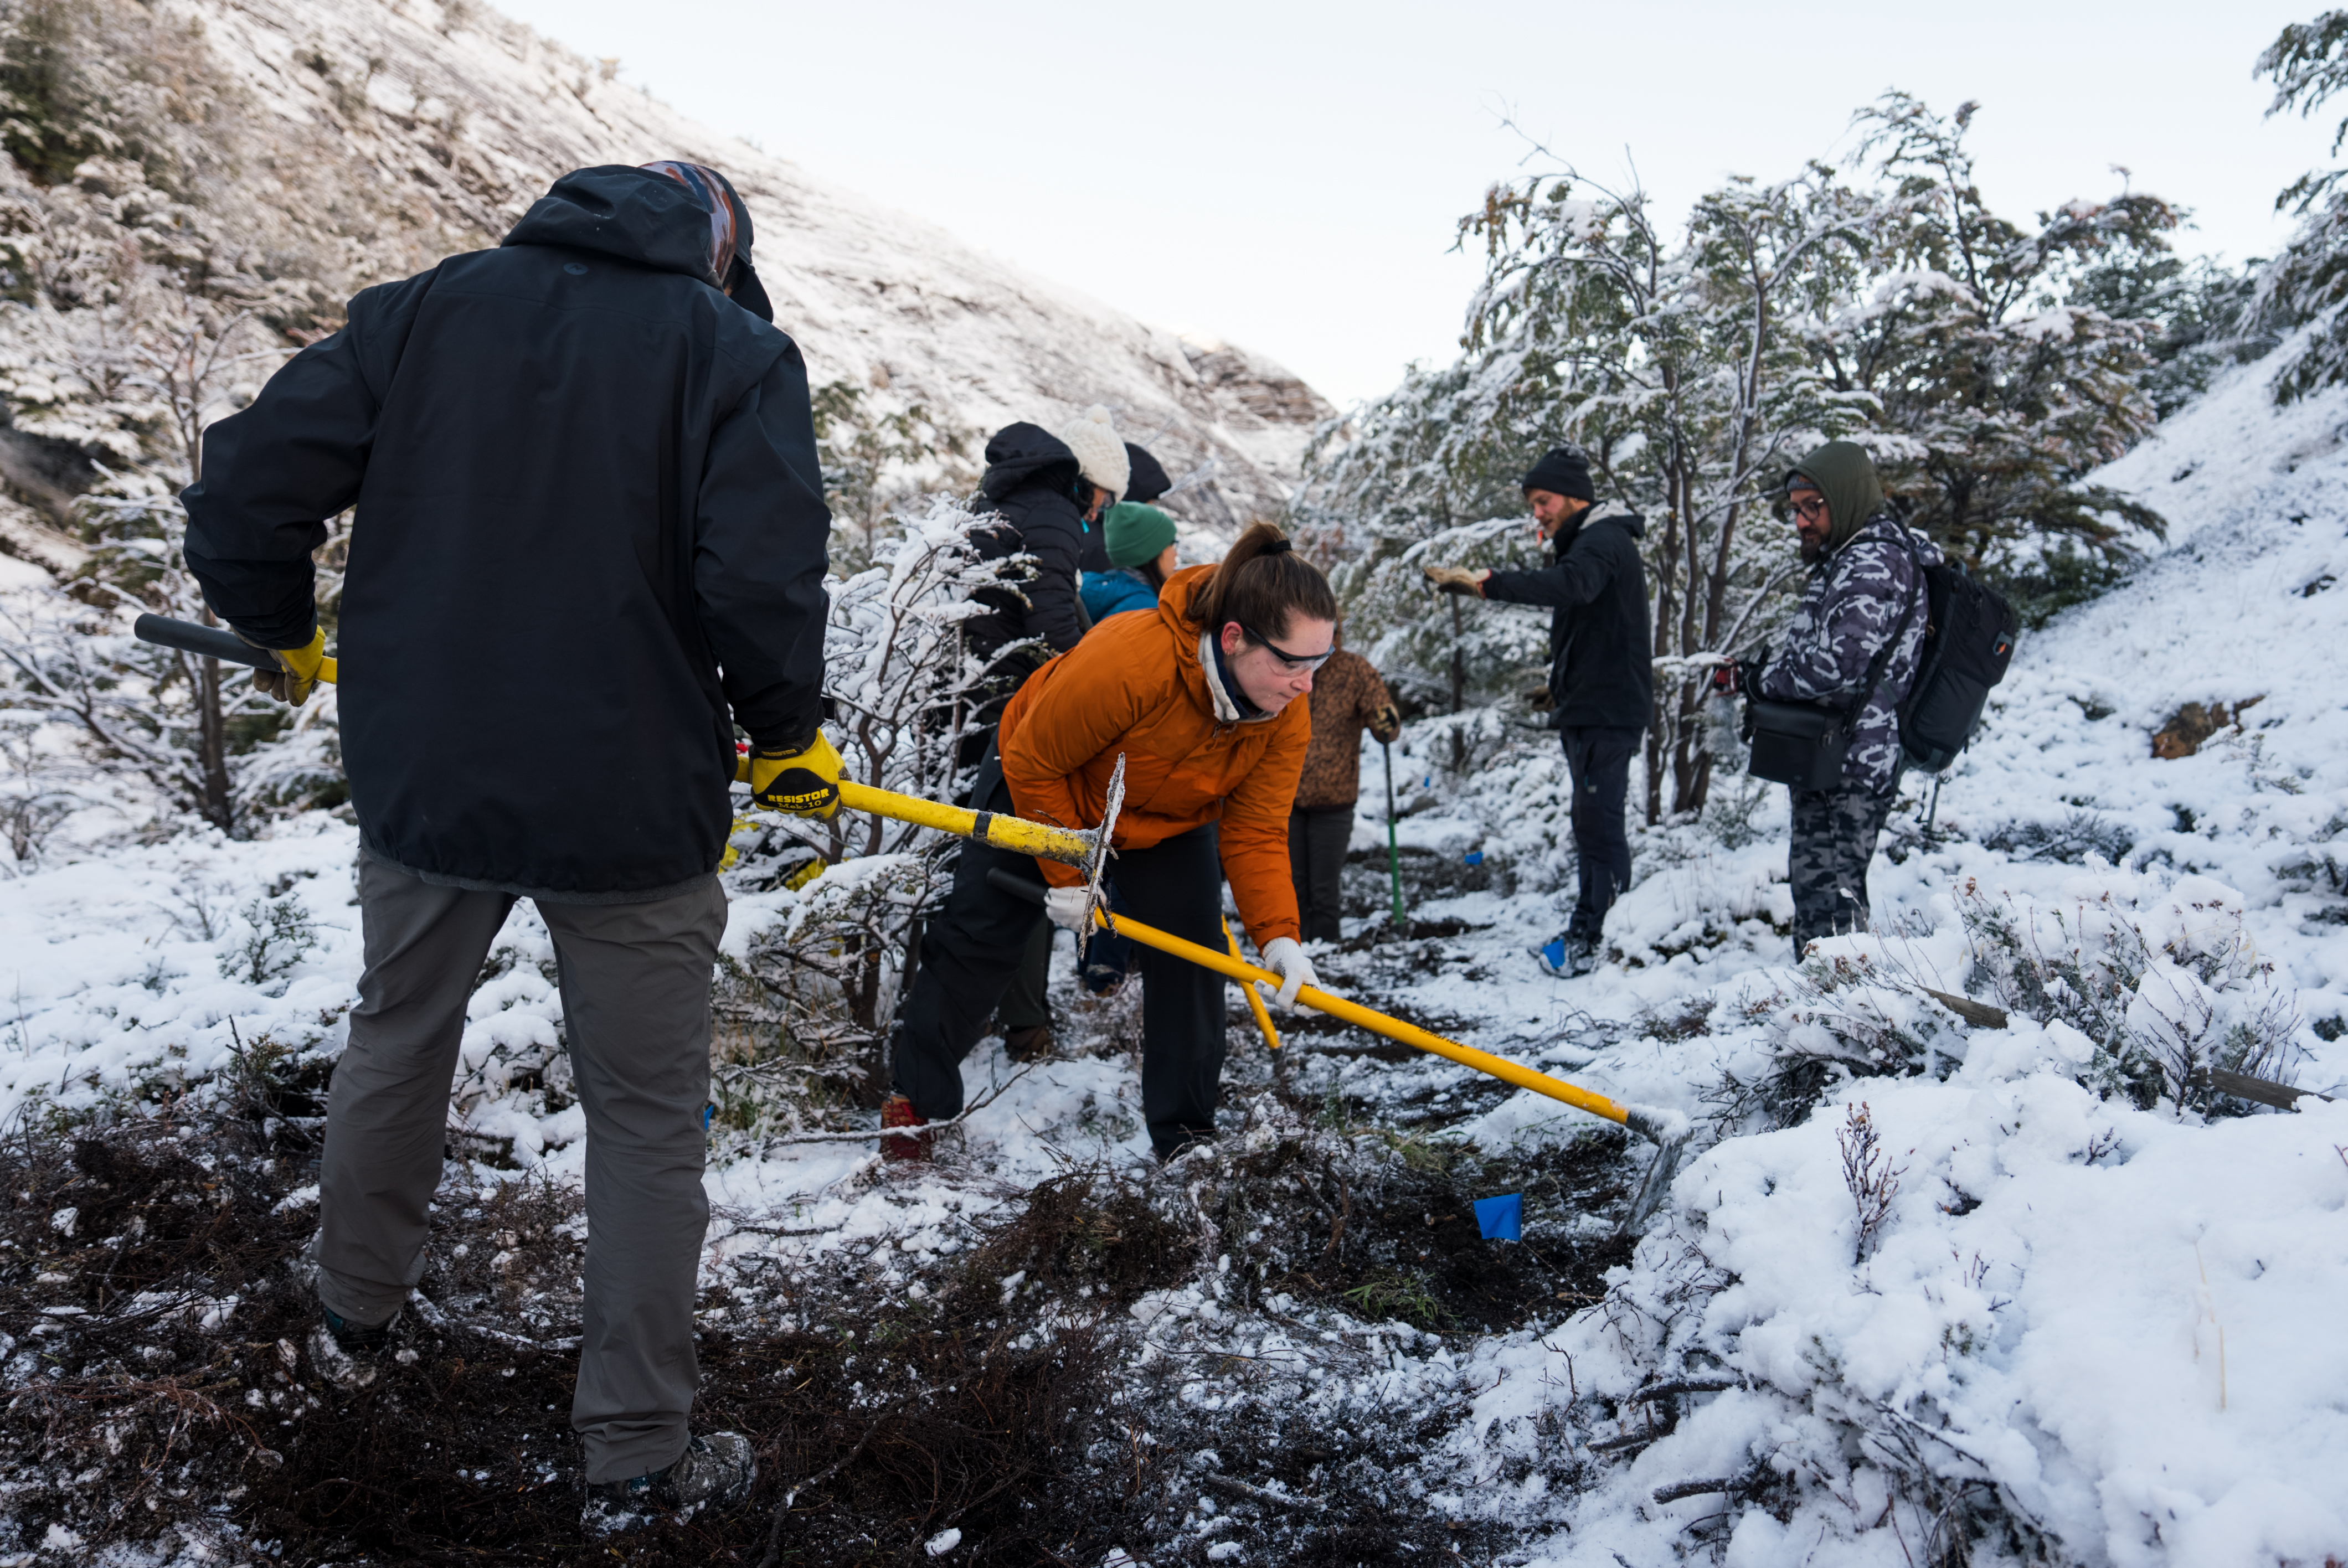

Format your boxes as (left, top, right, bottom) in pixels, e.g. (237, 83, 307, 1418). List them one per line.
(1728, 441, 1942, 960)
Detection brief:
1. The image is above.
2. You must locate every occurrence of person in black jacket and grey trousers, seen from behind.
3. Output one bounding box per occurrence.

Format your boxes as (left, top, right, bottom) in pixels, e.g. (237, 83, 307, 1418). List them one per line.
(186, 162, 841, 1528)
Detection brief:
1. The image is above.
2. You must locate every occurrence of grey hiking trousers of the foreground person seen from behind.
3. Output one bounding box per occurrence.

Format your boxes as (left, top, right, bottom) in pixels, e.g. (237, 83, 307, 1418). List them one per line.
(317, 859, 725, 1481)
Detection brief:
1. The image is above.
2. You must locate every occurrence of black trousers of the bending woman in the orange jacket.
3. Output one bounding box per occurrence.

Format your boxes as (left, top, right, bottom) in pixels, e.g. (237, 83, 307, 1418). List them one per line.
(890, 751, 1228, 1153)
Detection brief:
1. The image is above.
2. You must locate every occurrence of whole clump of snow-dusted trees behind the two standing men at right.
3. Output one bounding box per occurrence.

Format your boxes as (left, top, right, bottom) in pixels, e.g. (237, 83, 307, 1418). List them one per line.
(1299, 94, 2188, 822)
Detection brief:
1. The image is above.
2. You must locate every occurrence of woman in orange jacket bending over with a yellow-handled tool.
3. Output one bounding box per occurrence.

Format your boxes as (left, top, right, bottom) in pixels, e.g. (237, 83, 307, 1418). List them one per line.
(881, 523, 1336, 1159)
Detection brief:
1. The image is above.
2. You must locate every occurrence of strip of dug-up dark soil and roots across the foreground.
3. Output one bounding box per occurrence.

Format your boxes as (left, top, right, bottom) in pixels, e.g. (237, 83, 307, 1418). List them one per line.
(0, 1096, 1652, 1568)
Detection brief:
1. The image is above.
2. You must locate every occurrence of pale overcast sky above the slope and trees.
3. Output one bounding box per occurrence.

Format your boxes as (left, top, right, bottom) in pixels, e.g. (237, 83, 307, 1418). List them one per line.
(498, 0, 2348, 401)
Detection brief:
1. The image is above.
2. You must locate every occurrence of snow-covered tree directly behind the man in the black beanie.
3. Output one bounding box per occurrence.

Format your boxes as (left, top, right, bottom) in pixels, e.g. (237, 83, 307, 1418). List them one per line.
(1310, 151, 1874, 819)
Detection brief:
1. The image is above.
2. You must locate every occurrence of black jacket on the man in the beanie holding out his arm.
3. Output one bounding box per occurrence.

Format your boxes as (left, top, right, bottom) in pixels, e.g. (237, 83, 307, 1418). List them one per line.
(1484, 507, 1655, 730)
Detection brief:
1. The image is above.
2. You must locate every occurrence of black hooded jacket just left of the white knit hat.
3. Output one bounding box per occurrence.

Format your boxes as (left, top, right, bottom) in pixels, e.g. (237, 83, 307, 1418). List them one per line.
(965, 422, 1087, 669)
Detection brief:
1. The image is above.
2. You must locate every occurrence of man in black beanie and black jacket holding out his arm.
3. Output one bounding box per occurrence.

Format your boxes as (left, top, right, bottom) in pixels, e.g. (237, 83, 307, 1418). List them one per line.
(1425, 446, 1655, 977)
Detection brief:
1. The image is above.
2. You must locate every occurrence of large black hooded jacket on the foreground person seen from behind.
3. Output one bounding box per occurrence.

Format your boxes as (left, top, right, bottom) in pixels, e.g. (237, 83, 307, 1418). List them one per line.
(186, 167, 829, 904)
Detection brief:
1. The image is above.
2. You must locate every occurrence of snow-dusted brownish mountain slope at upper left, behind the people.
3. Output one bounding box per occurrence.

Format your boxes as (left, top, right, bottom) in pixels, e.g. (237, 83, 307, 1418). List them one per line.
(0, 0, 1329, 568)
